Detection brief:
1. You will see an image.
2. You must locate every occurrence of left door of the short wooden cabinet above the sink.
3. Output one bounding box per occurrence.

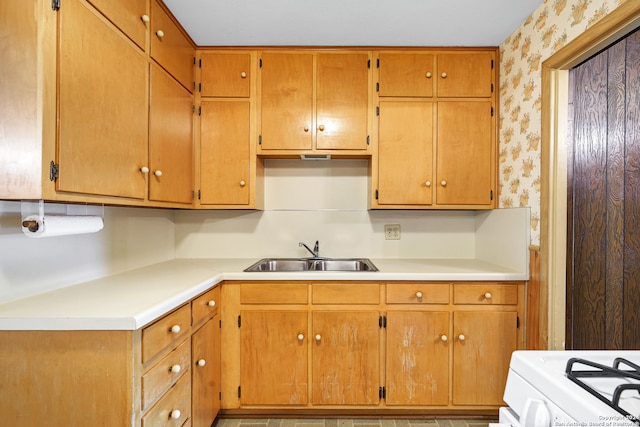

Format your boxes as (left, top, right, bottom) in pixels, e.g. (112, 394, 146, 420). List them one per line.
(260, 52, 315, 150)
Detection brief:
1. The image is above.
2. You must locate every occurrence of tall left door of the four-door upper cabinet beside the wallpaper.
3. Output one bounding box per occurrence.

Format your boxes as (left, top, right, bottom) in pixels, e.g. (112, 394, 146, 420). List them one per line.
(378, 101, 434, 205)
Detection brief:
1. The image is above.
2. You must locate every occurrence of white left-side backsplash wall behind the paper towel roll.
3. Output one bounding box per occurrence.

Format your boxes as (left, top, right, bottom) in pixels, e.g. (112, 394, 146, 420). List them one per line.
(0, 201, 175, 303)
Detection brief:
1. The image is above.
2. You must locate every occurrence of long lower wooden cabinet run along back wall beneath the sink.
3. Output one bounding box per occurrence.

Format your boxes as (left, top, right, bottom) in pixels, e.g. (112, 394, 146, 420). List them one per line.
(221, 282, 525, 415)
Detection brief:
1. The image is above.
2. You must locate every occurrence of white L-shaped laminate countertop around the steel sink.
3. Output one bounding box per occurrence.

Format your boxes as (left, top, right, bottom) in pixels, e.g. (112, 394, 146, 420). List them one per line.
(0, 258, 528, 330)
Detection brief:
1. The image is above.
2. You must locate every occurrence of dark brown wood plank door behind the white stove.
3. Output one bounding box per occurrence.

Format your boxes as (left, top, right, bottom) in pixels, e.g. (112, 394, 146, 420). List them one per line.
(566, 31, 640, 349)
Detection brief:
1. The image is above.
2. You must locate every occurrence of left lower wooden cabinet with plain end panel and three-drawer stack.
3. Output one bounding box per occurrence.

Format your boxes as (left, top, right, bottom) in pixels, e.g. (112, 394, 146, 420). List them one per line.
(0, 288, 220, 427)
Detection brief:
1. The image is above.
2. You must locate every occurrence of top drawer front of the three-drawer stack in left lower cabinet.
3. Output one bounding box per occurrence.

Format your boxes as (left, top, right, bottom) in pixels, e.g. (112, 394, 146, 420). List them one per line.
(142, 304, 191, 363)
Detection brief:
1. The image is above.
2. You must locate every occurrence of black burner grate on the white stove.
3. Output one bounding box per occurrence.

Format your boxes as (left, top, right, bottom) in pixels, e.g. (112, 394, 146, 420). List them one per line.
(565, 357, 640, 425)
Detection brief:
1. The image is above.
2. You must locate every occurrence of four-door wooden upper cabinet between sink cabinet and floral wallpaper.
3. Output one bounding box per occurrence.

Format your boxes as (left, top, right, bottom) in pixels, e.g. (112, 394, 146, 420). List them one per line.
(370, 49, 497, 209)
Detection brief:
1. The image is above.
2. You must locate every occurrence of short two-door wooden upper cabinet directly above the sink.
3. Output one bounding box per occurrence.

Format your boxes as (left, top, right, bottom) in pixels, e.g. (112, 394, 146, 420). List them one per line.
(258, 51, 371, 155)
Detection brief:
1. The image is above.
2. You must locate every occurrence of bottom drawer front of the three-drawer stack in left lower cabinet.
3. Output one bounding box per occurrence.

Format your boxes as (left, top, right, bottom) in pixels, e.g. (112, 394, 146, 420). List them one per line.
(142, 375, 191, 427)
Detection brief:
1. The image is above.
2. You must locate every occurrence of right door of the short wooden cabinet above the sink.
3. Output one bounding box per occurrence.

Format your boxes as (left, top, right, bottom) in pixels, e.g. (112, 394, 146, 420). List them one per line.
(316, 53, 370, 150)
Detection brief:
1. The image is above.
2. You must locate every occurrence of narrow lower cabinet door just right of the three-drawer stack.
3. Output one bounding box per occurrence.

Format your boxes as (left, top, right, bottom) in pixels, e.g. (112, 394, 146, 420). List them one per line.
(191, 315, 220, 427)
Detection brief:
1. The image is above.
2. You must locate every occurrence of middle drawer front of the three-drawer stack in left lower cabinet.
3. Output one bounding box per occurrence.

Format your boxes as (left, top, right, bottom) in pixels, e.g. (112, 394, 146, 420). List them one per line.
(142, 340, 191, 411)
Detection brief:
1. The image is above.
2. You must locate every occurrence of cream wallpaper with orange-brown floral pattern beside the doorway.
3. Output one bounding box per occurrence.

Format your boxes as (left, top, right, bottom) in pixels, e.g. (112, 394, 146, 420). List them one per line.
(498, 0, 625, 245)
